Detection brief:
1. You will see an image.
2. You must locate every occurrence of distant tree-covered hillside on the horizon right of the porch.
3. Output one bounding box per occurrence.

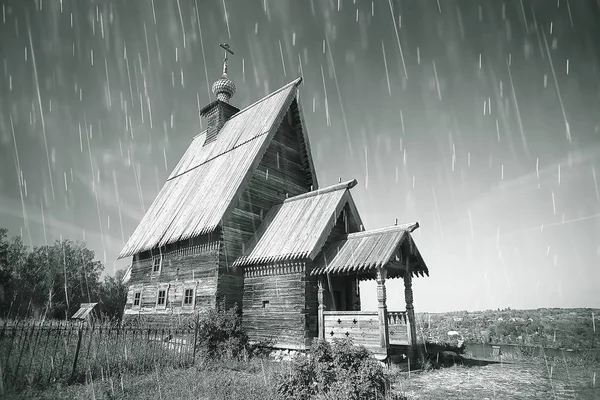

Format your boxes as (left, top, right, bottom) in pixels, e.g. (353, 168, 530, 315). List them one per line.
(416, 308, 600, 350)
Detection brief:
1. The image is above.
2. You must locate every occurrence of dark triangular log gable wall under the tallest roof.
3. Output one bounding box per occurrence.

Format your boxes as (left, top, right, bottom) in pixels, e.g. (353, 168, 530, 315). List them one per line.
(223, 104, 313, 263)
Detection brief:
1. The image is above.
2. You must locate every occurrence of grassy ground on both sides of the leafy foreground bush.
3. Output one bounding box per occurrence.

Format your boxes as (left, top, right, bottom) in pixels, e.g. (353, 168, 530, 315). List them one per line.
(6, 358, 600, 400)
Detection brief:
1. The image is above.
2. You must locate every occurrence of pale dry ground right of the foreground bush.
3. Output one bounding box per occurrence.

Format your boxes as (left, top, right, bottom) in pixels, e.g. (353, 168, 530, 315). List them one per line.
(393, 360, 600, 400)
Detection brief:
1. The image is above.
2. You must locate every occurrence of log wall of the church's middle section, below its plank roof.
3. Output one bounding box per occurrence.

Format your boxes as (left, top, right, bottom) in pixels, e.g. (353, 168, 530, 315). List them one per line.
(242, 263, 316, 349)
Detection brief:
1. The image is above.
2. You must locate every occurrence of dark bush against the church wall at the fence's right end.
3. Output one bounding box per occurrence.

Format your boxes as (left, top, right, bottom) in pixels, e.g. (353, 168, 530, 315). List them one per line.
(196, 301, 248, 360)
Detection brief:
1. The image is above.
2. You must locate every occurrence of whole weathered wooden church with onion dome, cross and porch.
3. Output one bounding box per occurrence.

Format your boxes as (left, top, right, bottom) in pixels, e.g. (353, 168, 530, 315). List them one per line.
(119, 45, 428, 356)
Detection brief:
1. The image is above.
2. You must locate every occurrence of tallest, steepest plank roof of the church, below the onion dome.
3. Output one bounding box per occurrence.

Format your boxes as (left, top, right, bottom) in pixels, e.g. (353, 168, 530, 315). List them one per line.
(119, 78, 316, 258)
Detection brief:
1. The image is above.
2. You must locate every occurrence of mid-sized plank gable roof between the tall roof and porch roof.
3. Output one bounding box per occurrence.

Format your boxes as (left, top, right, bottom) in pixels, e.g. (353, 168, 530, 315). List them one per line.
(233, 179, 362, 266)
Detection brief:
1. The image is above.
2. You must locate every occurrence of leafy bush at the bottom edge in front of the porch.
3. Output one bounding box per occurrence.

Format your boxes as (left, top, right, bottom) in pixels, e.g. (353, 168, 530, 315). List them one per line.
(277, 340, 388, 400)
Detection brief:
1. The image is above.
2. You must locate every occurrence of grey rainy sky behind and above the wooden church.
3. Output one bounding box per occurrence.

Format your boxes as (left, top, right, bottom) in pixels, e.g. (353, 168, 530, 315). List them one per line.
(0, 0, 600, 312)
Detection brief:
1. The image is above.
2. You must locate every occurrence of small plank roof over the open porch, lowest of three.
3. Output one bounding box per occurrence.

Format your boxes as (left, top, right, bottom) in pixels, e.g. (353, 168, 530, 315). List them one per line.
(311, 222, 429, 278)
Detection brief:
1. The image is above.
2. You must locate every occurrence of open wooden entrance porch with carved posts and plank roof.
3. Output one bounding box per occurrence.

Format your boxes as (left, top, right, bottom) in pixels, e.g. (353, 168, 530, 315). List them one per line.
(312, 223, 429, 359)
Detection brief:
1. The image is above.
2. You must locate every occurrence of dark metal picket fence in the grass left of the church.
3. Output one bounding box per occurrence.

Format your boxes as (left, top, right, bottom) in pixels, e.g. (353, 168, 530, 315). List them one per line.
(0, 321, 197, 393)
